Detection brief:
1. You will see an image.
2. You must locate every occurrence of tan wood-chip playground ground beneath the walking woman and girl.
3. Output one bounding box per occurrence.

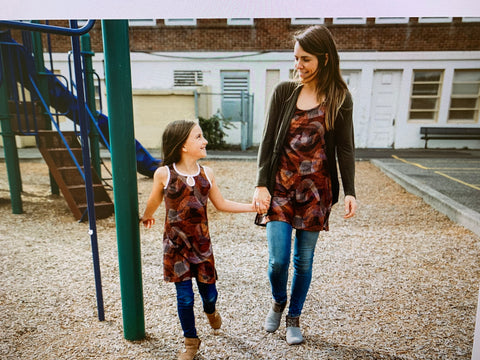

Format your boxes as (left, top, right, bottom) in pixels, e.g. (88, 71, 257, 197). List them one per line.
(0, 161, 480, 360)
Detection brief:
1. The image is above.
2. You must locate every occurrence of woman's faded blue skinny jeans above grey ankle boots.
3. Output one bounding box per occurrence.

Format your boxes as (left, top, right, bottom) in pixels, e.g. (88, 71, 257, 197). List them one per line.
(267, 221, 319, 317)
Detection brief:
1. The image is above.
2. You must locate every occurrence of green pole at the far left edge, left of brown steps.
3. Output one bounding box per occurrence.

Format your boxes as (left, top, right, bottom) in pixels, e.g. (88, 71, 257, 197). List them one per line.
(0, 44, 23, 214)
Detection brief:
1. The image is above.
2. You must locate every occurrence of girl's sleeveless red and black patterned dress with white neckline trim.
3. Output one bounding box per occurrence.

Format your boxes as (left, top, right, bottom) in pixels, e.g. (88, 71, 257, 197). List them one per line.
(163, 164, 217, 284)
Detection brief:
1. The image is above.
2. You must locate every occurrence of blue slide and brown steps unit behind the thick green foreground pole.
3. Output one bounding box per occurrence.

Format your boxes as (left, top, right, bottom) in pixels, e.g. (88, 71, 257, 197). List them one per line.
(1, 23, 160, 220)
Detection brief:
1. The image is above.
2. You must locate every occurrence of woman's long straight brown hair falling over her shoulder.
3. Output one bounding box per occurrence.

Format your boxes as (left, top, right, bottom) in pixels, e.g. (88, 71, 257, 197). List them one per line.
(294, 25, 348, 130)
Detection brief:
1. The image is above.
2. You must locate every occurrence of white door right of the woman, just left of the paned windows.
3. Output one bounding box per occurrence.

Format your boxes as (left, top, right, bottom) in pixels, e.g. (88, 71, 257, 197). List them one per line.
(367, 70, 402, 148)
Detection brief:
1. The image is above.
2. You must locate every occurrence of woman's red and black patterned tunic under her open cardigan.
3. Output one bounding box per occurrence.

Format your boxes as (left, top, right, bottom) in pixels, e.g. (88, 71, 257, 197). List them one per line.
(268, 106, 332, 231)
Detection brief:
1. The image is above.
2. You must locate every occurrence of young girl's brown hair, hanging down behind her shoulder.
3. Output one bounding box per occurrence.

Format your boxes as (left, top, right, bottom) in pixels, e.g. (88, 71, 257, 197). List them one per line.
(162, 120, 197, 165)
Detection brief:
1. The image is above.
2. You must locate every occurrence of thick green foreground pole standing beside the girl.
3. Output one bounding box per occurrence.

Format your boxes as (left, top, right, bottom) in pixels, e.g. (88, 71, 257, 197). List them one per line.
(102, 20, 145, 340)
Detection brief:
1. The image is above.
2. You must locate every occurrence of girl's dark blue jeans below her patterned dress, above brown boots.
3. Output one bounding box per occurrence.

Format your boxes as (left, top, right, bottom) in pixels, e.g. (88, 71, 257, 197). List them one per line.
(175, 280, 218, 338)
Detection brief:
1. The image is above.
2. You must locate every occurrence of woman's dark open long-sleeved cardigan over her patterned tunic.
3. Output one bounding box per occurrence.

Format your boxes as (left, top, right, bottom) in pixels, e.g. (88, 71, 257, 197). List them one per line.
(257, 81, 355, 205)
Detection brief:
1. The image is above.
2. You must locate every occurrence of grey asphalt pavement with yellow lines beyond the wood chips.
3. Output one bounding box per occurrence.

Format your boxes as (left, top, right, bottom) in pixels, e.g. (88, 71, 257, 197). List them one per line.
(0, 148, 480, 236)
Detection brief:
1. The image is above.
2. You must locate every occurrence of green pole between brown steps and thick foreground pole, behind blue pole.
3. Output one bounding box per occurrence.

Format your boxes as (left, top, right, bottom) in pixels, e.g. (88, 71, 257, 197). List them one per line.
(80, 34, 102, 178)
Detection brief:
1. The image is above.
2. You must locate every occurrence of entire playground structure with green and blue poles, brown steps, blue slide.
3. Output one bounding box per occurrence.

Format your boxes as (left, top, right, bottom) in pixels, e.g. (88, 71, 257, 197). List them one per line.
(0, 20, 146, 340)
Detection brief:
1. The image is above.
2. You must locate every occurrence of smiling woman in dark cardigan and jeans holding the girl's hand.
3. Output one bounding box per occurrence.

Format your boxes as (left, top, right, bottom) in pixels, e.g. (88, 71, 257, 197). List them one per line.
(253, 26, 357, 345)
